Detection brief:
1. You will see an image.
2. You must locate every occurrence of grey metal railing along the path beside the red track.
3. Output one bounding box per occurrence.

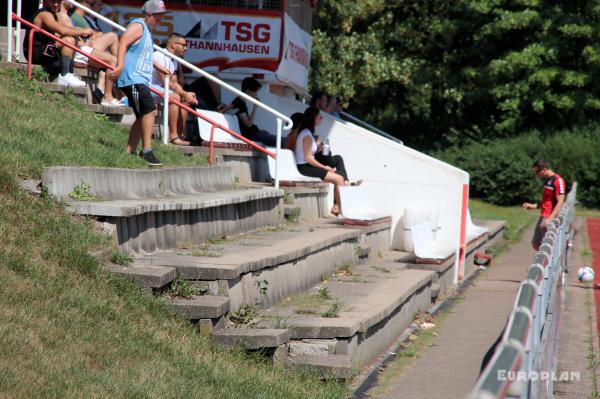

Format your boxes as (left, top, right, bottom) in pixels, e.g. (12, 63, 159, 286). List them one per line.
(471, 183, 577, 399)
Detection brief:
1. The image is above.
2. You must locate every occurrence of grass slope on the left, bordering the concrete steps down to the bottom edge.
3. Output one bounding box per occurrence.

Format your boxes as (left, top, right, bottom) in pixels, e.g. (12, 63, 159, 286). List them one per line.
(0, 70, 349, 399)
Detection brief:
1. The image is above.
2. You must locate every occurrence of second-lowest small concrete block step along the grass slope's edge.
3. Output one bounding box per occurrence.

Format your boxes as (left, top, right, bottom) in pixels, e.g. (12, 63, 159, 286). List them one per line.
(213, 328, 290, 349)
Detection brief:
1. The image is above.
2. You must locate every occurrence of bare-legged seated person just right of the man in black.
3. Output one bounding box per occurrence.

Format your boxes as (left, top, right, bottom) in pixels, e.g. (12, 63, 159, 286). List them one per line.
(59, 2, 124, 107)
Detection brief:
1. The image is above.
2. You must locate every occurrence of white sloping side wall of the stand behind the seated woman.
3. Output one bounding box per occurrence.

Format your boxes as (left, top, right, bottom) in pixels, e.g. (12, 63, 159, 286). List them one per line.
(223, 87, 469, 255)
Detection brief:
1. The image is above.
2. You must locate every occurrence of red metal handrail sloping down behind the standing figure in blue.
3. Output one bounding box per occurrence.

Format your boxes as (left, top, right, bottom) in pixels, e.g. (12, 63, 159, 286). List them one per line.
(11, 13, 276, 164)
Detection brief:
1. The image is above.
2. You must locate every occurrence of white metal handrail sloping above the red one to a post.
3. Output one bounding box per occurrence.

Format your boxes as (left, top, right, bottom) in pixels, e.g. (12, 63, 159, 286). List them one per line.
(65, 0, 293, 188)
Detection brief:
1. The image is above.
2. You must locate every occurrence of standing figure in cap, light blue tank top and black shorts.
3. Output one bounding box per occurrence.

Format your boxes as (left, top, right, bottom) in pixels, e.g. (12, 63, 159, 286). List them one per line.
(112, 0, 167, 166)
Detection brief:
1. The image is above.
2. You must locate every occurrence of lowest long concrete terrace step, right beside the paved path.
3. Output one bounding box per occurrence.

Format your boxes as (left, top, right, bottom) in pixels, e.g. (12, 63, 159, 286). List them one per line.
(258, 253, 436, 369)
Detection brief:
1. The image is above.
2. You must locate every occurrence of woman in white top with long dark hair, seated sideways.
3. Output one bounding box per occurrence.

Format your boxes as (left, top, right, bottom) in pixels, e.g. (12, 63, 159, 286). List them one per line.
(295, 107, 347, 216)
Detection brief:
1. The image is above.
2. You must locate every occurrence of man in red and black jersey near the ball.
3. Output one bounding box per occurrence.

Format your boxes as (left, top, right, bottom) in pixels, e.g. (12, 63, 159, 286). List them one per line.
(523, 159, 567, 251)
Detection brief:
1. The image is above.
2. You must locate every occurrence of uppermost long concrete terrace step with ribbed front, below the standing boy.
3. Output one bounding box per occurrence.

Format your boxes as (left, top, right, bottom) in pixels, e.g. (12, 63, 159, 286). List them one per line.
(43, 166, 283, 252)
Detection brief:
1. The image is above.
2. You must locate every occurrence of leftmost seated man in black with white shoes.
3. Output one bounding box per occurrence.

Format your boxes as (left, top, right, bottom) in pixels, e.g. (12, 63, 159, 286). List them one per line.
(23, 0, 94, 87)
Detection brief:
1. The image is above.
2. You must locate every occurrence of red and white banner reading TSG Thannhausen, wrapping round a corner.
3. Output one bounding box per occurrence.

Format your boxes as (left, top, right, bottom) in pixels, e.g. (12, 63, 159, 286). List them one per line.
(102, 0, 312, 89)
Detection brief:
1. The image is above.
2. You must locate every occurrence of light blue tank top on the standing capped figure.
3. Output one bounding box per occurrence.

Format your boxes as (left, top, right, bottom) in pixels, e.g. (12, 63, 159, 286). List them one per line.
(117, 18, 153, 87)
